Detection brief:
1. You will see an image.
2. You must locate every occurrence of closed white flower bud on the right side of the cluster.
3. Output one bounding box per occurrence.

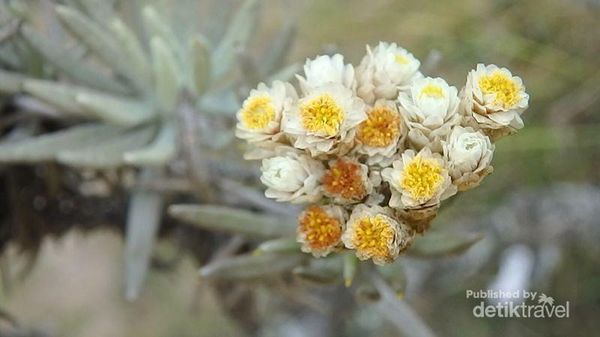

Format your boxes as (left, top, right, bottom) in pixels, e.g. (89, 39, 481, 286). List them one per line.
(444, 126, 494, 191)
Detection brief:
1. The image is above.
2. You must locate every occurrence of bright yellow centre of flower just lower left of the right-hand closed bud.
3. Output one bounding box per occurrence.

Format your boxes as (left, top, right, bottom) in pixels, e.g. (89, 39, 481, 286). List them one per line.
(400, 156, 444, 203)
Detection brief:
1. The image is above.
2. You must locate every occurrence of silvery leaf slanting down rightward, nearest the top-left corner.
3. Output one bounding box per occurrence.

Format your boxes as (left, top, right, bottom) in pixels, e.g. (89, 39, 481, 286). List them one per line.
(21, 26, 129, 93)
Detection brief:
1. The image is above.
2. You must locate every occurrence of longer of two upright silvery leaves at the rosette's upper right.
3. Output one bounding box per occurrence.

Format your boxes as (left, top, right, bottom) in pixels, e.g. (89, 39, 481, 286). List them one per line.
(150, 36, 181, 114)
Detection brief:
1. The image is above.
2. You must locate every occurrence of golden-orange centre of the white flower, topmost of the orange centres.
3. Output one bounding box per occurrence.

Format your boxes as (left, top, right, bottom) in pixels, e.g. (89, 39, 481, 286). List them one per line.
(356, 107, 400, 147)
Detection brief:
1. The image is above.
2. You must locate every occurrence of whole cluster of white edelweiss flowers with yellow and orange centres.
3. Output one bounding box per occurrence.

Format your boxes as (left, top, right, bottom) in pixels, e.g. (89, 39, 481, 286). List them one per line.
(236, 42, 529, 264)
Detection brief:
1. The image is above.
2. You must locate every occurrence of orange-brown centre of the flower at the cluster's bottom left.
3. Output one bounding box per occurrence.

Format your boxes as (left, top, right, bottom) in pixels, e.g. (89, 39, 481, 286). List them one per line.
(298, 205, 342, 249)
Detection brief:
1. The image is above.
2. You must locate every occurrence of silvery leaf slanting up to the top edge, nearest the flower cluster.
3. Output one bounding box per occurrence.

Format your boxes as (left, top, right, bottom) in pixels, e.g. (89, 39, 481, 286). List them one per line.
(212, 0, 259, 78)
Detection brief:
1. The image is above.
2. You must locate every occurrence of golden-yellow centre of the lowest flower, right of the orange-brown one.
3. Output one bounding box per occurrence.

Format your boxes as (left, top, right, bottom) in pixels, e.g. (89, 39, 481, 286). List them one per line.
(352, 214, 394, 257)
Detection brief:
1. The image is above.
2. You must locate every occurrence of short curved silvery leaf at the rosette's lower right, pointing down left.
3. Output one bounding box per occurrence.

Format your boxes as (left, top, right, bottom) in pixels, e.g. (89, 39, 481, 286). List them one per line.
(124, 122, 177, 166)
